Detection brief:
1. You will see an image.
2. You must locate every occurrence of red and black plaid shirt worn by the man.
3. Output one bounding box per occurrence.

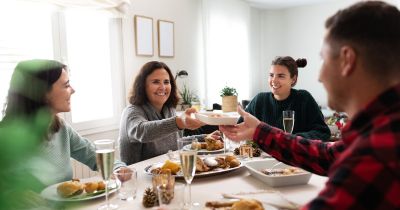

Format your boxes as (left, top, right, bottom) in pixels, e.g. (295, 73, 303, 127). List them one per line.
(253, 124, 400, 210)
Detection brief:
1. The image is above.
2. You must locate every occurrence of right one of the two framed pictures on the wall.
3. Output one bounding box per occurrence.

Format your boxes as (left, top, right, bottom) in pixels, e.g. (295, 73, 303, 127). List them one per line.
(157, 20, 174, 57)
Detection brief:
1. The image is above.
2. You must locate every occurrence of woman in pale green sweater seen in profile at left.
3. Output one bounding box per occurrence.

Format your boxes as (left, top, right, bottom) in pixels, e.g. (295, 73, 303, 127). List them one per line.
(1, 60, 125, 185)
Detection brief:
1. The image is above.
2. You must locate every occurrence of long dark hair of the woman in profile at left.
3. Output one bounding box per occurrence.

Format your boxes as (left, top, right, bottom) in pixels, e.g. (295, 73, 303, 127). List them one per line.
(3, 60, 66, 133)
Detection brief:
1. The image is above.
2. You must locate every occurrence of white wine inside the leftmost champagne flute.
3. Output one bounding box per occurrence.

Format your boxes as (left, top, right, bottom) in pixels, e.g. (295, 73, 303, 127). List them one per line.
(96, 149, 115, 180)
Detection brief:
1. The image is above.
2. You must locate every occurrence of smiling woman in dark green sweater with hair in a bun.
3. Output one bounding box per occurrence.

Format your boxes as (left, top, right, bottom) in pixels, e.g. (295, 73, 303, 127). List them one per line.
(239, 56, 330, 140)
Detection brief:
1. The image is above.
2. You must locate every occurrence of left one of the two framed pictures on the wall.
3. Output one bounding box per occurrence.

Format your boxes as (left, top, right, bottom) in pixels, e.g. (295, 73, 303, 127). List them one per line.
(134, 15, 154, 56)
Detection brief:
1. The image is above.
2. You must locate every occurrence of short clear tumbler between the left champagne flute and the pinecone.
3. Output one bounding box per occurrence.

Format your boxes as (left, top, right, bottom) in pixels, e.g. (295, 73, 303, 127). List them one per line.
(114, 168, 137, 201)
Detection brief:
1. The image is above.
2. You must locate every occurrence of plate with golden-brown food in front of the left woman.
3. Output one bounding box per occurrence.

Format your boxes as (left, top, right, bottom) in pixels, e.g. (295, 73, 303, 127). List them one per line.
(40, 179, 119, 202)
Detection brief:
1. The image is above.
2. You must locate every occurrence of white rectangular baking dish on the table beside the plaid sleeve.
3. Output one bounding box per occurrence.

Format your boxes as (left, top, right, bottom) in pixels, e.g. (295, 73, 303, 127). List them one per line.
(245, 159, 311, 187)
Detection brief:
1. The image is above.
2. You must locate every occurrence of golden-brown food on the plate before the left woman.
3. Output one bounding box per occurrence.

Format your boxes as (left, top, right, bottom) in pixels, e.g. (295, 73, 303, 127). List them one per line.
(57, 179, 105, 198)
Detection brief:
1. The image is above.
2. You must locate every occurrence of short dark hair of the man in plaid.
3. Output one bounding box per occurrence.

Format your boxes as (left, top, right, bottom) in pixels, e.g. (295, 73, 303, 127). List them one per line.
(325, 1, 400, 77)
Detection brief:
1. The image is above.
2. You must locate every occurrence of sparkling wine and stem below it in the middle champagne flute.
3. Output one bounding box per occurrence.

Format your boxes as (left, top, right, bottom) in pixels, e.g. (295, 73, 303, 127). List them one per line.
(179, 150, 197, 209)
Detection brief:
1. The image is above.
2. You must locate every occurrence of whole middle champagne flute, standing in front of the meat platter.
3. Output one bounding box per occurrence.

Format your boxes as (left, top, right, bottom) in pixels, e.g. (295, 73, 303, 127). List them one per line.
(178, 137, 197, 209)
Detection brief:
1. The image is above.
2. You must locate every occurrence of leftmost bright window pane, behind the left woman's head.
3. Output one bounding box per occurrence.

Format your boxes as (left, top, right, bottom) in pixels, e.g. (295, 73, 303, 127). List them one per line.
(0, 1, 53, 120)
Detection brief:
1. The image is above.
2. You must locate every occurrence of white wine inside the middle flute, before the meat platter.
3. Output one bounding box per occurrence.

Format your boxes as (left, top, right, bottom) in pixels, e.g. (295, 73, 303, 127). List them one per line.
(179, 151, 197, 184)
